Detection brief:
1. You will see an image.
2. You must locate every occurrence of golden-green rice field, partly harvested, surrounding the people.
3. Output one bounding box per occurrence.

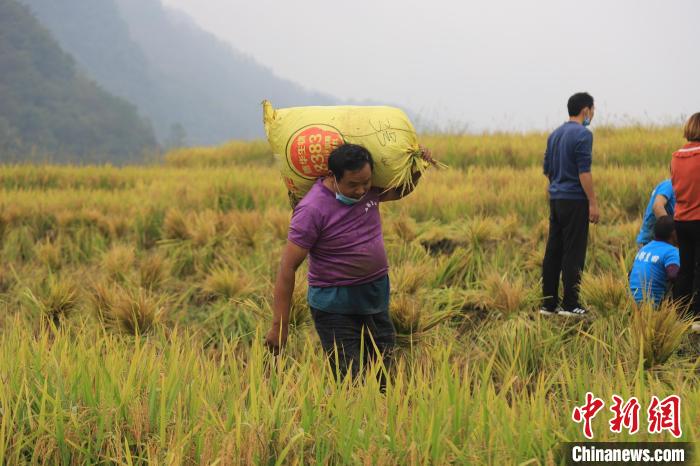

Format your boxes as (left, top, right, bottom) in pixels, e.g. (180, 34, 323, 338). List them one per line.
(0, 127, 700, 465)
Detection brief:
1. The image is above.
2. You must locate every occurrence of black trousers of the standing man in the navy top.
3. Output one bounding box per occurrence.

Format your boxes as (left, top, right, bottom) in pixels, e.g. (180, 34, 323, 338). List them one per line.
(542, 199, 589, 311)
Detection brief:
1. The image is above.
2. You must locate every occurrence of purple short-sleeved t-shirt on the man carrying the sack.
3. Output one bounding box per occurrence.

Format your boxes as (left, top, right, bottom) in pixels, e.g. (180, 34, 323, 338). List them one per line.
(287, 178, 389, 287)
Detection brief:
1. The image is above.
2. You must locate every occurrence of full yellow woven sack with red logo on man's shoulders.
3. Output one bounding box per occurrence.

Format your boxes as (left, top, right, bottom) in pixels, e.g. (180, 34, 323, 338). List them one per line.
(263, 100, 428, 204)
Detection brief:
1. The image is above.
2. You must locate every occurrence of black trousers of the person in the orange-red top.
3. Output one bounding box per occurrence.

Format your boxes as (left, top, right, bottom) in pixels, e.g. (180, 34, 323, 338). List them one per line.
(673, 220, 700, 317)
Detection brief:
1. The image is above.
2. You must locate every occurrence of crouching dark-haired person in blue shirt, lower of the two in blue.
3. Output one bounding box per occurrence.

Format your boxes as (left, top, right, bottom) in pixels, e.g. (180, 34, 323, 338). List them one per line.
(630, 215, 681, 306)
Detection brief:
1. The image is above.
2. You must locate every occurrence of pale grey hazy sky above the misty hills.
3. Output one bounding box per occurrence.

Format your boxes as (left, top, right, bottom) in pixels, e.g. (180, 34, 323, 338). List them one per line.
(163, 0, 700, 130)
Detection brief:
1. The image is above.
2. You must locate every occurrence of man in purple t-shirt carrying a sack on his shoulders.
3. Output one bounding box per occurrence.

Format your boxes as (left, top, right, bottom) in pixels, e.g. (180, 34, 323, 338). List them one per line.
(265, 144, 435, 387)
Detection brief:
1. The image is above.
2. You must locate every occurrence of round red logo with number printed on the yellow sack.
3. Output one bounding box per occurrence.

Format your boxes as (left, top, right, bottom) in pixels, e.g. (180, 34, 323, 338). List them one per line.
(287, 125, 345, 179)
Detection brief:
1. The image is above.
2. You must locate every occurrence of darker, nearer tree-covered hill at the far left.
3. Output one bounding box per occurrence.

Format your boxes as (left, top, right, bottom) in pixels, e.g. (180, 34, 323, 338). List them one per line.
(0, 0, 156, 162)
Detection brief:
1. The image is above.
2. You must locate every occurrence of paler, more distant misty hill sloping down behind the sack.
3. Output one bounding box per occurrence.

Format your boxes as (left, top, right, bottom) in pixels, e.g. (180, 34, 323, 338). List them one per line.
(22, 0, 337, 146)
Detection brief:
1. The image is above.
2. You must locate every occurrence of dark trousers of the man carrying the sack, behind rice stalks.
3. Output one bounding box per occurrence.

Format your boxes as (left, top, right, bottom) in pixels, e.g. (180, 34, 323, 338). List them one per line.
(311, 308, 396, 390)
